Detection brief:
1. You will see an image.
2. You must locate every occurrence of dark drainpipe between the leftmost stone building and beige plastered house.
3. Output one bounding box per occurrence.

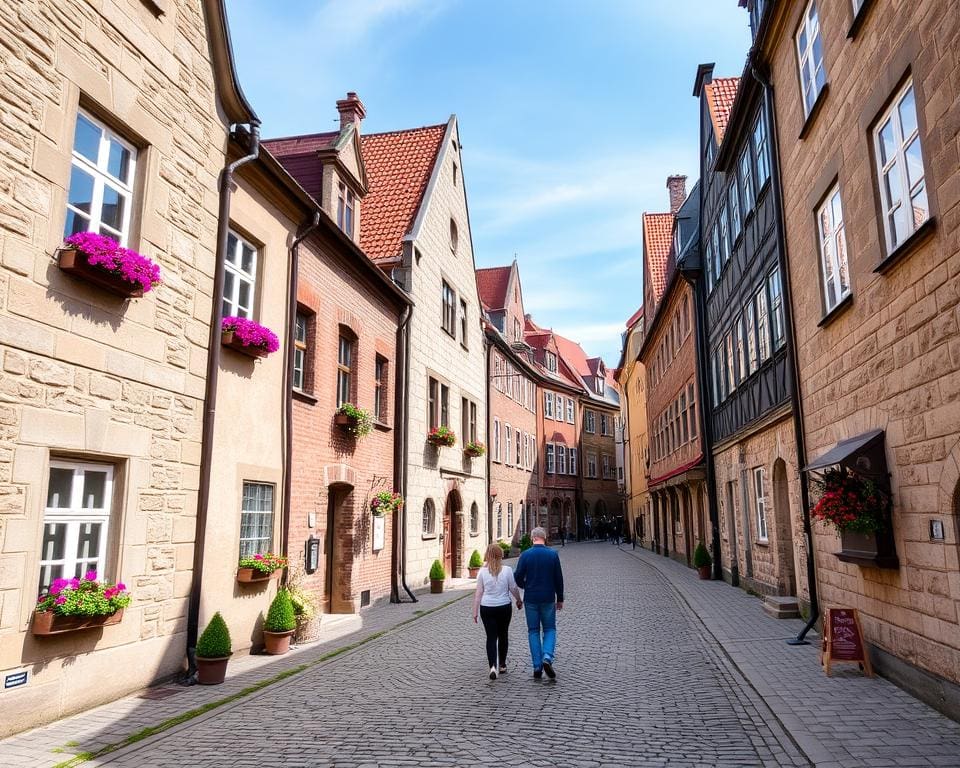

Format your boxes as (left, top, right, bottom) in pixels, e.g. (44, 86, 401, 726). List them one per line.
(187, 120, 260, 680)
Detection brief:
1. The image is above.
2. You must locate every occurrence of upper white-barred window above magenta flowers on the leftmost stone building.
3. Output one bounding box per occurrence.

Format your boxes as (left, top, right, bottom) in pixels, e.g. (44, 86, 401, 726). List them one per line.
(64, 111, 137, 246)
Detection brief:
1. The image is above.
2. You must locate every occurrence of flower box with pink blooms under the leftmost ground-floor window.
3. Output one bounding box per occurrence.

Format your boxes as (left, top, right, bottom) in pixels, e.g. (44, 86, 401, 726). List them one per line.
(32, 571, 131, 635)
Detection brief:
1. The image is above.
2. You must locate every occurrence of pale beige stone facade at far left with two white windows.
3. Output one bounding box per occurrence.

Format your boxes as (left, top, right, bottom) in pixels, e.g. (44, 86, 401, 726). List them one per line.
(0, 0, 255, 733)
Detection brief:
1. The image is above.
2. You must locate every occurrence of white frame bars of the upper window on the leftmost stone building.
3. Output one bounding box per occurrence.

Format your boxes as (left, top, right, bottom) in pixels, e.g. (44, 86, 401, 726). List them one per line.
(64, 109, 137, 246)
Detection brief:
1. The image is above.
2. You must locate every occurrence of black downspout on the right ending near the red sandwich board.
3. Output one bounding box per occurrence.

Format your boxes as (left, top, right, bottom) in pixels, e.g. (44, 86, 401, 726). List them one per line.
(750, 57, 820, 645)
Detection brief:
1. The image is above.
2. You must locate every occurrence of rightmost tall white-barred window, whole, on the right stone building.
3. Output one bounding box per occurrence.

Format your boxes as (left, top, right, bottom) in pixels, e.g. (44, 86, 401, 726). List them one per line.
(874, 81, 930, 253)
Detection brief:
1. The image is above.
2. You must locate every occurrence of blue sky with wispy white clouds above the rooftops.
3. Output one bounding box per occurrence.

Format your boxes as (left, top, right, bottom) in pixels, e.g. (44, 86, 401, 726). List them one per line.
(227, 0, 750, 365)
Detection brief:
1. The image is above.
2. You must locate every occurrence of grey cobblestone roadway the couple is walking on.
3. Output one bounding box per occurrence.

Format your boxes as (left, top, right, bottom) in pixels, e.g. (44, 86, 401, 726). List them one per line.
(95, 543, 809, 768)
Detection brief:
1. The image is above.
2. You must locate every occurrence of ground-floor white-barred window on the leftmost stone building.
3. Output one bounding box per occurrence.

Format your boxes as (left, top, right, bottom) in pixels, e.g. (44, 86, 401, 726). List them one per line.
(39, 462, 113, 593)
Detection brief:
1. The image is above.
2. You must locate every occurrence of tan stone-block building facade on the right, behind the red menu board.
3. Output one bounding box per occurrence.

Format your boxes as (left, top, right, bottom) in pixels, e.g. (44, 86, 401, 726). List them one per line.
(751, 0, 960, 712)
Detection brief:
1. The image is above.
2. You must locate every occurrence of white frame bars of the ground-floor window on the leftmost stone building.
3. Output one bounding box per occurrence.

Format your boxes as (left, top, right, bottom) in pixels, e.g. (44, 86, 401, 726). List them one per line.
(39, 460, 114, 590)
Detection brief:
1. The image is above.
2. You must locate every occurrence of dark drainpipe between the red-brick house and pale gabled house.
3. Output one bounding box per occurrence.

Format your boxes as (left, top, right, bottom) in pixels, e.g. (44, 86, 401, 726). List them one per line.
(390, 305, 418, 603)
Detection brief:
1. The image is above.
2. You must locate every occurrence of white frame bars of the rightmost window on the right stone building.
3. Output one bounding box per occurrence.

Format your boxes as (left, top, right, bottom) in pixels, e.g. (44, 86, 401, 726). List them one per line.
(873, 78, 930, 254)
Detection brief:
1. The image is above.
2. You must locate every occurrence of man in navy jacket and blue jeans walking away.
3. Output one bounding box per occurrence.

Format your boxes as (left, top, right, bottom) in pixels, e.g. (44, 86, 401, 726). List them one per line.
(514, 526, 563, 680)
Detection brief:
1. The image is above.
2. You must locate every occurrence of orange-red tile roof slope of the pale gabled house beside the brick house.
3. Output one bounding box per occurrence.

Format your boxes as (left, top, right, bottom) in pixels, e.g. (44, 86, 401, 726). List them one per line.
(360, 124, 447, 261)
